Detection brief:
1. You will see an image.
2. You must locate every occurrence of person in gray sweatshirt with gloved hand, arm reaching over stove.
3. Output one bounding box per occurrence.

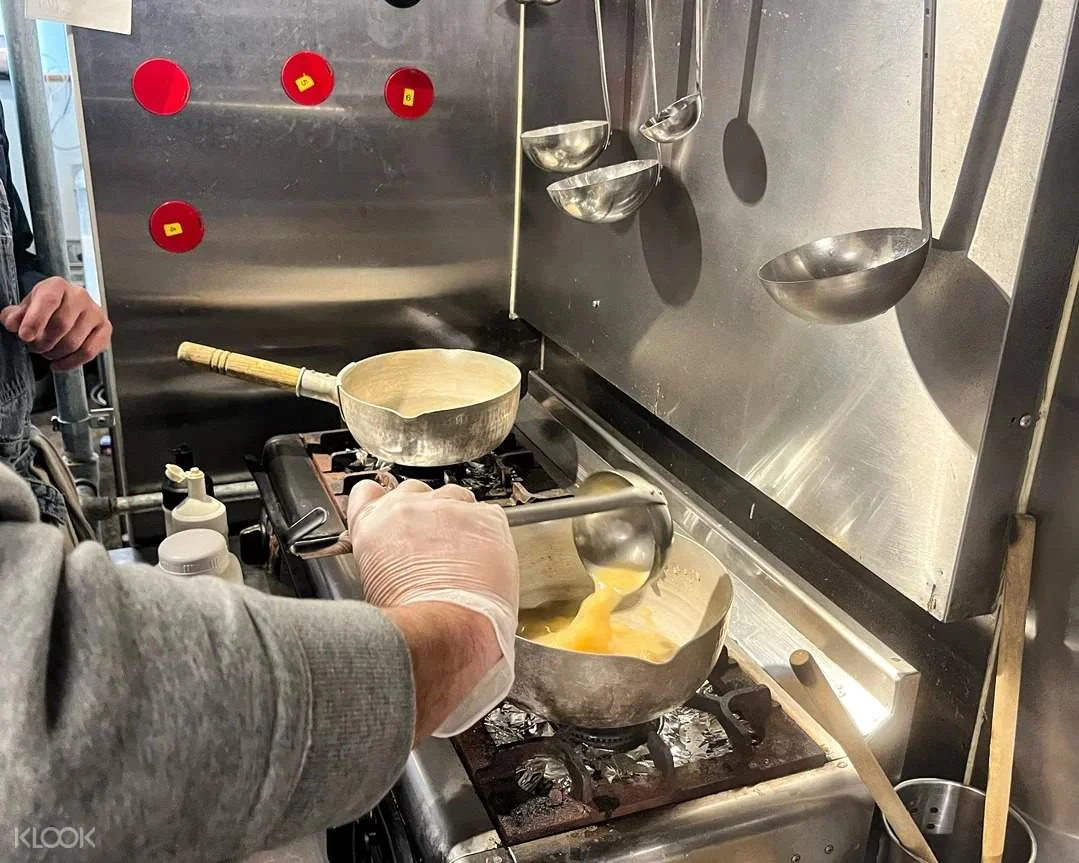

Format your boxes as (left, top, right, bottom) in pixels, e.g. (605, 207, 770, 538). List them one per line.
(0, 463, 518, 863)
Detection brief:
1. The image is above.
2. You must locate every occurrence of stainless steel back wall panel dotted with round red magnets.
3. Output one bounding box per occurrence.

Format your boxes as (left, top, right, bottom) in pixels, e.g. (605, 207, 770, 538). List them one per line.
(74, 0, 535, 502)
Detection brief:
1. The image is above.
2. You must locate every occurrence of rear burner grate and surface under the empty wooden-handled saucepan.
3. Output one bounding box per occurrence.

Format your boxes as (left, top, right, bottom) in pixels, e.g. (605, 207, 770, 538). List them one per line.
(301, 429, 569, 512)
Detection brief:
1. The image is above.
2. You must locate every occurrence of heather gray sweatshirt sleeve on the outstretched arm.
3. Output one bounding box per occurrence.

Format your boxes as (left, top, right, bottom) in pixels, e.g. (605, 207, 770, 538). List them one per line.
(0, 464, 414, 861)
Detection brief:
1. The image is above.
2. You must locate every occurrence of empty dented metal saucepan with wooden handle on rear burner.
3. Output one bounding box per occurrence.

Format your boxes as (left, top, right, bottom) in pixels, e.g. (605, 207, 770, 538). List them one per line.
(176, 342, 521, 467)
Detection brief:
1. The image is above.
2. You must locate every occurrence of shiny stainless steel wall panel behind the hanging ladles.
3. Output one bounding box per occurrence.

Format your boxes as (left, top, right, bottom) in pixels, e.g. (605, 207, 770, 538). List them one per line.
(517, 0, 1075, 619)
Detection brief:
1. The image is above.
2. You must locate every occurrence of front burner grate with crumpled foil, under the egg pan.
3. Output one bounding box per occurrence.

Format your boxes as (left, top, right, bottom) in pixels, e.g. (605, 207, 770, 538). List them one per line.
(453, 650, 827, 845)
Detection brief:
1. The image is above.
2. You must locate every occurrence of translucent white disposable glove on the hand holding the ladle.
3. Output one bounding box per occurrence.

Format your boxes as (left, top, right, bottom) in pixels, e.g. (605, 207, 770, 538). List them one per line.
(349, 480, 518, 737)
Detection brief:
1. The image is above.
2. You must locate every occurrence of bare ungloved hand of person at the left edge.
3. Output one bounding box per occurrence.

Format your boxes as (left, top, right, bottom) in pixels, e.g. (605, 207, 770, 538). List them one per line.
(0, 276, 112, 371)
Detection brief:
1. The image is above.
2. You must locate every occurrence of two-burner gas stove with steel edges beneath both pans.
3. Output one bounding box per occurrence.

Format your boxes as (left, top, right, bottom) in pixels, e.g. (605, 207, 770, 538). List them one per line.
(251, 375, 916, 863)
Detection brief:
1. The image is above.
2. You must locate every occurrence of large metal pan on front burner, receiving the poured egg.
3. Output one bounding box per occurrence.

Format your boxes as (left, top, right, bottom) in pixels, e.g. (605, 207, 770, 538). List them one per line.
(509, 521, 734, 729)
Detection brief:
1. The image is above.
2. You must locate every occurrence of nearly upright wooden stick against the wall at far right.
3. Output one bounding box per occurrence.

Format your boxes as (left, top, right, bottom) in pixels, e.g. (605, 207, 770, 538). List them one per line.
(982, 516, 1036, 863)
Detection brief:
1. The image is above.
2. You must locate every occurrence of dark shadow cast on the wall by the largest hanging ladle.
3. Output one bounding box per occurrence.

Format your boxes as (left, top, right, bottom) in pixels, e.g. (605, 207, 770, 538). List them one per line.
(896, 0, 1041, 450)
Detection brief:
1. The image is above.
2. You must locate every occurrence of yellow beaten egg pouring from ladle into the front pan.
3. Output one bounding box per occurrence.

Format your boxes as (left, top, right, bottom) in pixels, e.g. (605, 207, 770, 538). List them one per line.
(517, 569, 678, 662)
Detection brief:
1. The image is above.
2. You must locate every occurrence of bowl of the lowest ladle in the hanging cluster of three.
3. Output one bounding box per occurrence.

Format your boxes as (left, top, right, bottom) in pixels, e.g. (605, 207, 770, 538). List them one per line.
(547, 159, 659, 224)
